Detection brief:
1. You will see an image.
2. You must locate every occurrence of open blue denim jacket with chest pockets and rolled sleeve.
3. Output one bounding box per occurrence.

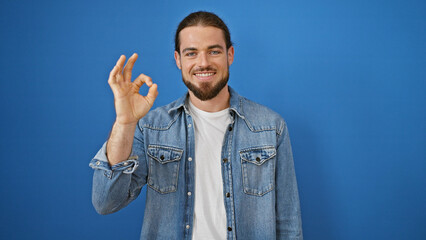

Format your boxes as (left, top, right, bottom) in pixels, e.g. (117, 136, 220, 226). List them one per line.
(90, 88, 303, 240)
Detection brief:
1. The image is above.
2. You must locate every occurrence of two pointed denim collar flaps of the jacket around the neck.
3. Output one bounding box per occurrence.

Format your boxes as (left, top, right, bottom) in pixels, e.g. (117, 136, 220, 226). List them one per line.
(168, 85, 245, 119)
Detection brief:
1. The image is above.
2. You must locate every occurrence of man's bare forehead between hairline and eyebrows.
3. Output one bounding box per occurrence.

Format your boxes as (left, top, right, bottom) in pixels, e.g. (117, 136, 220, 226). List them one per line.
(179, 26, 226, 49)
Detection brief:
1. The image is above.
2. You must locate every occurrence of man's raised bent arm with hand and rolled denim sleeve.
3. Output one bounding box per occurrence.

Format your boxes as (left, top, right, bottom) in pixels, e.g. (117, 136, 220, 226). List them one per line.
(90, 54, 158, 214)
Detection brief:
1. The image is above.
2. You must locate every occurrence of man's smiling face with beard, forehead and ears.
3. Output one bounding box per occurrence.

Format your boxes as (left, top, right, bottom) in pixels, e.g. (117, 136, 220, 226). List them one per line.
(175, 26, 234, 101)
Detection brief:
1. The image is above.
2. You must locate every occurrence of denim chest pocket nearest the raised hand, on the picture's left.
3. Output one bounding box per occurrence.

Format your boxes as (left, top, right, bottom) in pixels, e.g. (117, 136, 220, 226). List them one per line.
(147, 145, 183, 193)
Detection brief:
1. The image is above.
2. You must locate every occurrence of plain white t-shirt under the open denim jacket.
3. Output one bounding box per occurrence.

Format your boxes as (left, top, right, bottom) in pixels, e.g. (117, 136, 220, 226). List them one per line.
(187, 100, 231, 240)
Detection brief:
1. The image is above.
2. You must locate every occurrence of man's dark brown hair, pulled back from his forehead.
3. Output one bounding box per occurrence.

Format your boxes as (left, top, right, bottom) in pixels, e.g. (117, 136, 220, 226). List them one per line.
(175, 11, 232, 54)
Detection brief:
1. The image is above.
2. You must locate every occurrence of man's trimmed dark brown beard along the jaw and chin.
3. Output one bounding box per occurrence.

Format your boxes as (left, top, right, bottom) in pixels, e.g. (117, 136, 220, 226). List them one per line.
(182, 67, 229, 101)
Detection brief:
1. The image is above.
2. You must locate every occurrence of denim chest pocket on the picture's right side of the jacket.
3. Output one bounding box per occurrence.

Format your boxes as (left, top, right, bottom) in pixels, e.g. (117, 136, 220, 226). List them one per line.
(240, 146, 277, 196)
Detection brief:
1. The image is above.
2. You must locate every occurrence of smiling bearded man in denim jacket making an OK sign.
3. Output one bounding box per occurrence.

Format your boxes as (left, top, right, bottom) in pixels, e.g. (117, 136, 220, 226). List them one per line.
(90, 12, 303, 240)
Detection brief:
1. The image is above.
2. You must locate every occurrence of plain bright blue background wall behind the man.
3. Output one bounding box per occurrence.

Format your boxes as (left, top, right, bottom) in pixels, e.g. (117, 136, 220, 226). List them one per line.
(0, 0, 426, 240)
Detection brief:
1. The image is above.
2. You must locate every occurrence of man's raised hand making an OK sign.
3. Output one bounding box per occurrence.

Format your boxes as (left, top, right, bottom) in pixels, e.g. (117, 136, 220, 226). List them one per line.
(108, 53, 158, 125)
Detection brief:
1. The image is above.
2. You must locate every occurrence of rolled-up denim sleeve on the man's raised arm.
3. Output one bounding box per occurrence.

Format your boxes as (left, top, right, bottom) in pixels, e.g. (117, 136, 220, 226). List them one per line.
(89, 125, 148, 215)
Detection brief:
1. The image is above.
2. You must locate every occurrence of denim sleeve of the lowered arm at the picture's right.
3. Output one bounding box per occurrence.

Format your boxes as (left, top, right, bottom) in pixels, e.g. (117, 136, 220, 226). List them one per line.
(276, 122, 303, 240)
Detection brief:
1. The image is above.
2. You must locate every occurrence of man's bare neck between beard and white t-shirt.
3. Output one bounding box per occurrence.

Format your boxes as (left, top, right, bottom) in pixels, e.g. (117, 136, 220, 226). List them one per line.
(189, 85, 231, 112)
